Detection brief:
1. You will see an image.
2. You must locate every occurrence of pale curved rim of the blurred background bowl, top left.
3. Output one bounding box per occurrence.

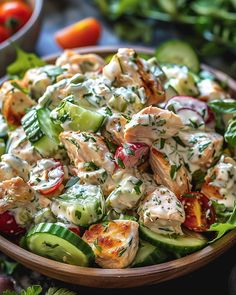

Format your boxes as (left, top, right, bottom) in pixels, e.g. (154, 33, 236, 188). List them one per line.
(0, 0, 44, 50)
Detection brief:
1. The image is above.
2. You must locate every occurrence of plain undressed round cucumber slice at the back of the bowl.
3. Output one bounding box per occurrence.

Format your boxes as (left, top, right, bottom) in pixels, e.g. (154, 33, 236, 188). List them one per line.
(156, 40, 200, 73)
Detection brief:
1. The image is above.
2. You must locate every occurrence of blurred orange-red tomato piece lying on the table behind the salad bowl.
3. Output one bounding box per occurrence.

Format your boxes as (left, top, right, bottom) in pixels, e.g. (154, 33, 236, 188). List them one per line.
(54, 17, 102, 49)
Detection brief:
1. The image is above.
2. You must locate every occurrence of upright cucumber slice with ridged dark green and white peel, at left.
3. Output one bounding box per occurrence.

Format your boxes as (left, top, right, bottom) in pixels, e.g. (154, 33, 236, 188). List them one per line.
(21, 108, 62, 157)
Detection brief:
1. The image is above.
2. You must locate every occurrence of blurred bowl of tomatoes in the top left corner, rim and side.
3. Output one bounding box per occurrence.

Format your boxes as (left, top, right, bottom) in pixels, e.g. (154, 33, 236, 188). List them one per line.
(0, 0, 43, 77)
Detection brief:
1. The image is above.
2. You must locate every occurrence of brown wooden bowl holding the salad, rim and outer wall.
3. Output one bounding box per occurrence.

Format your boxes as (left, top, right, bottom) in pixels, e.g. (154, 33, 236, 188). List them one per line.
(0, 46, 236, 288)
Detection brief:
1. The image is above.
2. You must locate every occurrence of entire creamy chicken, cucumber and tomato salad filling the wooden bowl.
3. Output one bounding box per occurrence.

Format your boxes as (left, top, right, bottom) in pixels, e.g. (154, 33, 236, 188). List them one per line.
(0, 41, 236, 268)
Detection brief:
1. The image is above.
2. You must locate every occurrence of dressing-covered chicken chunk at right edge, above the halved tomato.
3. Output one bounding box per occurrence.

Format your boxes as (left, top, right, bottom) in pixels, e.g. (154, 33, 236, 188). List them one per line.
(201, 155, 236, 210)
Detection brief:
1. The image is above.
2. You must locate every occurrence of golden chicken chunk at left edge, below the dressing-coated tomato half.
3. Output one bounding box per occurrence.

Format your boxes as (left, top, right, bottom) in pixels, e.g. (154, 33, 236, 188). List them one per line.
(0, 176, 34, 214)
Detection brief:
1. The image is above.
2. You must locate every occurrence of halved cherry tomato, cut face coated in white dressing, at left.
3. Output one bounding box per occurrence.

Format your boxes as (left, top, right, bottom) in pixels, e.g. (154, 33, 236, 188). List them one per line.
(29, 159, 65, 195)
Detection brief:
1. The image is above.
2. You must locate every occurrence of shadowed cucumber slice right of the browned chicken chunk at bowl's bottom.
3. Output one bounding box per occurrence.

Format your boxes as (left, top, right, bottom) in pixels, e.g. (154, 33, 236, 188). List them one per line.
(131, 240, 171, 267)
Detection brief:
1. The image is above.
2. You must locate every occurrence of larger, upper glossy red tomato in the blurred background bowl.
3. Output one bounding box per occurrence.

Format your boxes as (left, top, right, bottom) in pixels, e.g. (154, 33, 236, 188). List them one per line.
(0, 1, 32, 32)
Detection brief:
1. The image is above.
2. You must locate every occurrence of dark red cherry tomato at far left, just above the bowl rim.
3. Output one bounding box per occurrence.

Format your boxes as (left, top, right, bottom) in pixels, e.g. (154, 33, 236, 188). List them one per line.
(0, 211, 25, 236)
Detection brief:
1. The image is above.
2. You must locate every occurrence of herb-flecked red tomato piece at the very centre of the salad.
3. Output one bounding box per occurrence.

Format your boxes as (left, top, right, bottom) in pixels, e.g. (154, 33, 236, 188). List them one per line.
(115, 143, 149, 169)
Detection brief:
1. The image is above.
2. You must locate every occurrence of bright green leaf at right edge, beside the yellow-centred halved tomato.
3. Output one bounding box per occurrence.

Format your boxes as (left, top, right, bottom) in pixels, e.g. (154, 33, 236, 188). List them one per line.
(208, 205, 236, 243)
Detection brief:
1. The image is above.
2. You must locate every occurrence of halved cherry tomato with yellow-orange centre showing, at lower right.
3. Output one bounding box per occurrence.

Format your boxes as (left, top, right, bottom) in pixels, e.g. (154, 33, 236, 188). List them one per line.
(180, 192, 216, 232)
